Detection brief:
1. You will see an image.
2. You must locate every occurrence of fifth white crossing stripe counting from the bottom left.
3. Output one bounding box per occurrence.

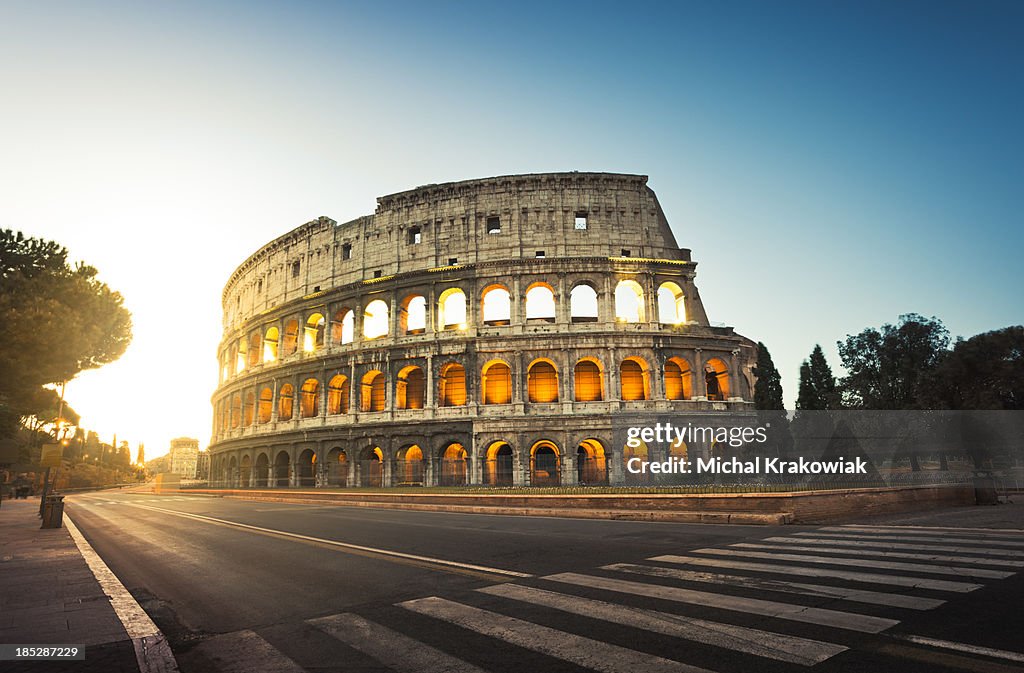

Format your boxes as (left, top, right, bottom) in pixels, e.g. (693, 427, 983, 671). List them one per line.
(541, 573, 899, 633)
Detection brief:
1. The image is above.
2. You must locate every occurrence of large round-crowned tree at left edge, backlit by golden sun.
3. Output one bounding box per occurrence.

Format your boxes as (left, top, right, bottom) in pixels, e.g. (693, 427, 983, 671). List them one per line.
(0, 229, 131, 436)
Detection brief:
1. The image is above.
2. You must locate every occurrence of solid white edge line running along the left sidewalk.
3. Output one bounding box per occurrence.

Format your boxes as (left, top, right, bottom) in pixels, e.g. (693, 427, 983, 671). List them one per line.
(65, 513, 178, 673)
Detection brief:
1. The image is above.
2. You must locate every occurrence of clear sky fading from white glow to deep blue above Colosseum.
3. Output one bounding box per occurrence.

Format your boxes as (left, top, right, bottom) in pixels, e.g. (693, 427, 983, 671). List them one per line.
(0, 1, 1024, 455)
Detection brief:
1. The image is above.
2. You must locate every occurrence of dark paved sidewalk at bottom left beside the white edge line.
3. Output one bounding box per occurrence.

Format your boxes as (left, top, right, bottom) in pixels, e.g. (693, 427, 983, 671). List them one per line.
(0, 498, 139, 673)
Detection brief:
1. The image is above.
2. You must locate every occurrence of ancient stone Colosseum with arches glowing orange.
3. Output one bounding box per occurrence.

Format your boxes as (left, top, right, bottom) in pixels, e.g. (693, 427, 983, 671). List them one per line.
(211, 172, 757, 488)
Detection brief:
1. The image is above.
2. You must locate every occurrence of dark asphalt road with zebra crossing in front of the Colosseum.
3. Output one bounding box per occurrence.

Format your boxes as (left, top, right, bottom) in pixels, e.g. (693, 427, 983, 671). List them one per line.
(68, 493, 1024, 673)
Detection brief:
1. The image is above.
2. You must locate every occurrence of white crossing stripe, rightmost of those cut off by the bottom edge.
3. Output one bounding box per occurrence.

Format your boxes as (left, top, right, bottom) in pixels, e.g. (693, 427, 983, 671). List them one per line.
(398, 597, 710, 673)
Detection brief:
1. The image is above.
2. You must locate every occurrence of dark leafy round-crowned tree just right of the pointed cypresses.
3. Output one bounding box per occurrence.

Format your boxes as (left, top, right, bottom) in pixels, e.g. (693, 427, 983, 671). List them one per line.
(838, 313, 949, 410)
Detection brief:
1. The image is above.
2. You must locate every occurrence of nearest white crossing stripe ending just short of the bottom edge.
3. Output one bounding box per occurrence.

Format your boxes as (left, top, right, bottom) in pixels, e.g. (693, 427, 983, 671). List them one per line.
(477, 584, 847, 666)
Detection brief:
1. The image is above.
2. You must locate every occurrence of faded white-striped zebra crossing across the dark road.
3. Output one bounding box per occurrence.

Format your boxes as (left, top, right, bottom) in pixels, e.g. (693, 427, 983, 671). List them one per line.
(182, 525, 1024, 673)
